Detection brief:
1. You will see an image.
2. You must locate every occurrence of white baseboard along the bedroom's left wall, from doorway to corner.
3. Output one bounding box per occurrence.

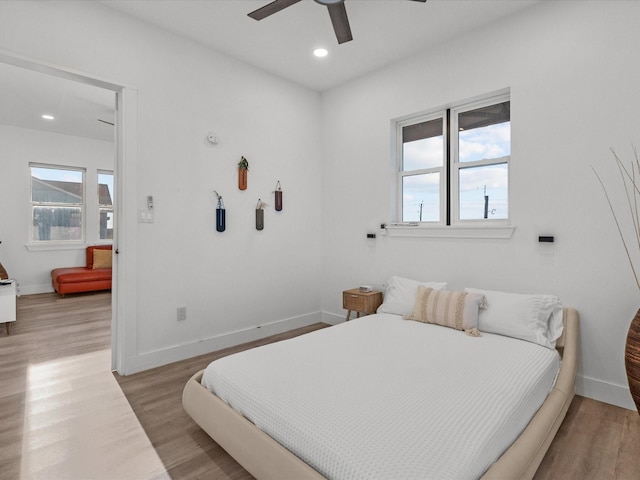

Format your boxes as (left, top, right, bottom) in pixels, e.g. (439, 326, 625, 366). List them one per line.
(119, 312, 321, 375)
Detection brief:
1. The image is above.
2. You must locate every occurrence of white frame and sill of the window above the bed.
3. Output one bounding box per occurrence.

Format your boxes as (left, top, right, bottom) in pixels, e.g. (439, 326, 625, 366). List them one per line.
(386, 89, 515, 238)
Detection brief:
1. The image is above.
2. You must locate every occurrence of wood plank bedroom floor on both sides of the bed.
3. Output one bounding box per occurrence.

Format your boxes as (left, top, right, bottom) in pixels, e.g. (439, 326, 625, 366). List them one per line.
(118, 334, 640, 480)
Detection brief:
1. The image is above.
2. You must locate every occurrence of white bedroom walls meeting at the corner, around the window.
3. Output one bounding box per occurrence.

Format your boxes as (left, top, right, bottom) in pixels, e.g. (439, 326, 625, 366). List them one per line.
(0, 1, 640, 408)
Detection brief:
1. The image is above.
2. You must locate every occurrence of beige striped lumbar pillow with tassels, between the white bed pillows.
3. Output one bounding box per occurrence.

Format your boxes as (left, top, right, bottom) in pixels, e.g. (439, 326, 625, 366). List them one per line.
(404, 286, 485, 331)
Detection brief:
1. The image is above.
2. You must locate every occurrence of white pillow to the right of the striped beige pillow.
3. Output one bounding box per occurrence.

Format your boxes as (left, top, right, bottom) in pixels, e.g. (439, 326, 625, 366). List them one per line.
(465, 288, 563, 348)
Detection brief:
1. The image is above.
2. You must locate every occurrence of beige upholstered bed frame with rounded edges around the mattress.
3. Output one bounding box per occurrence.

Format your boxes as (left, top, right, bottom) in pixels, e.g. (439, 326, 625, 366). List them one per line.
(182, 308, 579, 480)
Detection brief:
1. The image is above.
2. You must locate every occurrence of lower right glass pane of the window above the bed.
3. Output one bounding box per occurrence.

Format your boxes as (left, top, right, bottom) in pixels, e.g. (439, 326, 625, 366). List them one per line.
(458, 163, 509, 220)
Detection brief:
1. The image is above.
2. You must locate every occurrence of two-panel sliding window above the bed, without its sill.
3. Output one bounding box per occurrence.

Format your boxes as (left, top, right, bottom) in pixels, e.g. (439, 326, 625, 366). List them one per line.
(396, 95, 511, 225)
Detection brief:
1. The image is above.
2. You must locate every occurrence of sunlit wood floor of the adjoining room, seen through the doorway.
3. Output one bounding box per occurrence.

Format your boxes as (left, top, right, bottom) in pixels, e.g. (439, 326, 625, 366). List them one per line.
(0, 292, 170, 480)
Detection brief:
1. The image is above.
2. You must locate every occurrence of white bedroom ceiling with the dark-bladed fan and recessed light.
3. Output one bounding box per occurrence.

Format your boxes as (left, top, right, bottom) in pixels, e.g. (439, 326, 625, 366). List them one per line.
(101, 0, 540, 91)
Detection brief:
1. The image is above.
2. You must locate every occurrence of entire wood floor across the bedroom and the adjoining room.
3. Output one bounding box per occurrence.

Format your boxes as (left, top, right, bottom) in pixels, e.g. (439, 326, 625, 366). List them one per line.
(0, 293, 640, 480)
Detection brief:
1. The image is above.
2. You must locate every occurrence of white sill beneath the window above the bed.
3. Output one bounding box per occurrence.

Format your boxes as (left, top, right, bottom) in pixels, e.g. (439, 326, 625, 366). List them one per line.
(385, 225, 516, 239)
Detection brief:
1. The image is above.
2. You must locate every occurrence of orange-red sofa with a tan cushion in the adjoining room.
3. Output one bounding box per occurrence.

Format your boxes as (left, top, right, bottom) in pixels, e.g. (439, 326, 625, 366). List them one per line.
(51, 245, 111, 295)
